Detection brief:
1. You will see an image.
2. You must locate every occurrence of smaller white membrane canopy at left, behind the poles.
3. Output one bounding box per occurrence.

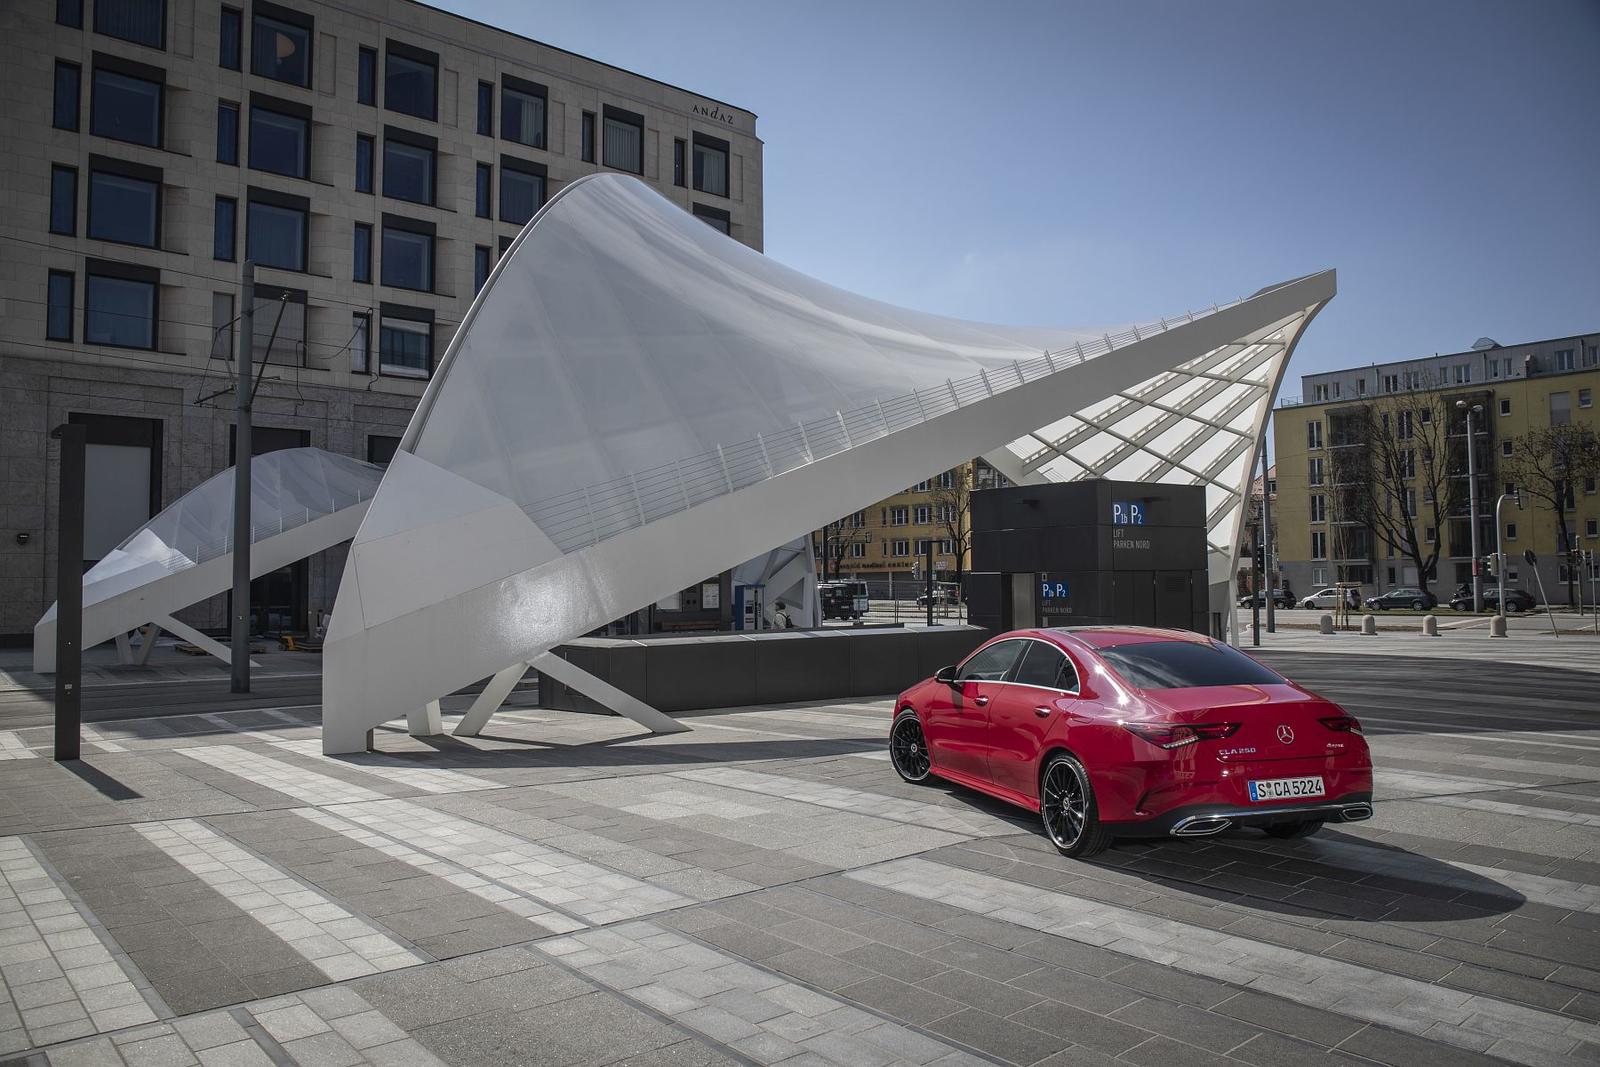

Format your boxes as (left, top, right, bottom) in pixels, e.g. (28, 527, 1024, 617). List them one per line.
(34, 448, 384, 670)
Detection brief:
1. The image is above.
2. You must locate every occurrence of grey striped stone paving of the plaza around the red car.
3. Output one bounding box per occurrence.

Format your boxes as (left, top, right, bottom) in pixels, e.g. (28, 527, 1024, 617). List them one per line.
(0, 643, 1600, 1067)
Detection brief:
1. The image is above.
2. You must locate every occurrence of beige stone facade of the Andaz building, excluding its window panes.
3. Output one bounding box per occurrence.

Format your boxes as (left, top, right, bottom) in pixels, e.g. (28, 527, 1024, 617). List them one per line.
(0, 0, 762, 638)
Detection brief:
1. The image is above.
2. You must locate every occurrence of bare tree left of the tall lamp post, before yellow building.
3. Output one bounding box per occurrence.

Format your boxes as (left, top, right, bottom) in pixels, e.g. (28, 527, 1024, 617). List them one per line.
(1328, 379, 1467, 592)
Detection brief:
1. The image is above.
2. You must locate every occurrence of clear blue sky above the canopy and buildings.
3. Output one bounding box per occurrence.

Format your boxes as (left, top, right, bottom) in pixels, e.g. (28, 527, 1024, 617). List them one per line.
(435, 0, 1600, 385)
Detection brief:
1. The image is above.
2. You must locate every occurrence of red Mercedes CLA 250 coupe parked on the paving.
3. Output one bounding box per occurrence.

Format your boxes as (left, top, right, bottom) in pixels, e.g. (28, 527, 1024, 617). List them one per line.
(890, 627, 1373, 856)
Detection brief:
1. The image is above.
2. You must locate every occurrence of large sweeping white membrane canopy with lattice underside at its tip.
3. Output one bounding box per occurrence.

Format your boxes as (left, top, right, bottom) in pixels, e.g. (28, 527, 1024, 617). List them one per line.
(325, 174, 1333, 752)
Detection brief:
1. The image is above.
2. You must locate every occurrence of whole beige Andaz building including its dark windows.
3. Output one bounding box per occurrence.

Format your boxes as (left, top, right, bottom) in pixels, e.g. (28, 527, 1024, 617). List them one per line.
(0, 0, 762, 637)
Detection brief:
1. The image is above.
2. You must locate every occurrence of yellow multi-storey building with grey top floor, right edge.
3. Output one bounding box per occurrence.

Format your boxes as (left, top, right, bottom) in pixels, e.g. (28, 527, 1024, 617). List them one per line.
(1272, 333, 1600, 603)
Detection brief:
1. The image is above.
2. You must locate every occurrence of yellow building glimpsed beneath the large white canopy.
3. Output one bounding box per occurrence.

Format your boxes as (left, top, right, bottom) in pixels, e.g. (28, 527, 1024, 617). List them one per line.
(811, 459, 1010, 581)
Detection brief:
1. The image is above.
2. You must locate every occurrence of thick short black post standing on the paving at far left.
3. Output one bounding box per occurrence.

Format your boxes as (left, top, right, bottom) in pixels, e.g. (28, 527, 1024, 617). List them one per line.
(50, 424, 85, 760)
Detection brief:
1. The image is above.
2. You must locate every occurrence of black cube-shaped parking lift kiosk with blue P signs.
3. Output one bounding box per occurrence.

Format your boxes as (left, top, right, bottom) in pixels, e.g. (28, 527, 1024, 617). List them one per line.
(966, 478, 1210, 633)
